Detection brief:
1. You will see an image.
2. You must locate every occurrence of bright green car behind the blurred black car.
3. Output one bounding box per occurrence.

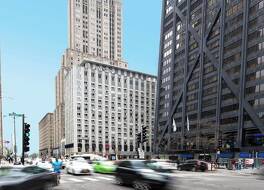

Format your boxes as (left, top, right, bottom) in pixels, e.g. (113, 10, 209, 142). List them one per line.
(93, 161, 116, 174)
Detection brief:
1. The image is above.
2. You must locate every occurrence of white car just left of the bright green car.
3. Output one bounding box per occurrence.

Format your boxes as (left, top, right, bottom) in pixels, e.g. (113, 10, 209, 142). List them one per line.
(66, 159, 93, 175)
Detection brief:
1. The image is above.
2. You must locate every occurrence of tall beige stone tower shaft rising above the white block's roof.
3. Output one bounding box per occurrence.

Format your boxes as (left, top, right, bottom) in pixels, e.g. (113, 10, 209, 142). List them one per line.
(69, 0, 127, 68)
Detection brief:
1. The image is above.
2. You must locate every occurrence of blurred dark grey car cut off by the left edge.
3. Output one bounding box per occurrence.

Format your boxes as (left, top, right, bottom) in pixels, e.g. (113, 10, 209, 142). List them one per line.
(0, 166, 59, 190)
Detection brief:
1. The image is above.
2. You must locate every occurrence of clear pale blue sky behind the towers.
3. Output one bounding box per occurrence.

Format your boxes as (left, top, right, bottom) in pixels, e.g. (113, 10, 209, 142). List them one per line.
(0, 0, 161, 154)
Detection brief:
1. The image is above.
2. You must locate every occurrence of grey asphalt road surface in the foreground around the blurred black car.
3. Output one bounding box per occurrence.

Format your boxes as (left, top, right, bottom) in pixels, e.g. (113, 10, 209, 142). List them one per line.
(55, 172, 264, 190)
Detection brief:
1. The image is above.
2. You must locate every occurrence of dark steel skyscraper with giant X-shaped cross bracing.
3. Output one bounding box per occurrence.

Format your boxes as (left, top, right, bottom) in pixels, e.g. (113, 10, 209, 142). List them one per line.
(155, 0, 264, 157)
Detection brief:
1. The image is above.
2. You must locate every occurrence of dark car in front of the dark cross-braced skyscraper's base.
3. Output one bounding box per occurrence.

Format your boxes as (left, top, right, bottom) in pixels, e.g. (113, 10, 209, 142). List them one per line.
(178, 160, 208, 172)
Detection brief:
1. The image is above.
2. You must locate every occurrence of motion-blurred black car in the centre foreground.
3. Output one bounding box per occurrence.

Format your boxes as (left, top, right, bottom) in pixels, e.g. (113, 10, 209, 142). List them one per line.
(115, 160, 170, 190)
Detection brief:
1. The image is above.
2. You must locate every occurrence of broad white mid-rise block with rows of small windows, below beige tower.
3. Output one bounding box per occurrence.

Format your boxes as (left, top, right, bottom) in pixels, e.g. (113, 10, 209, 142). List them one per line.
(65, 61, 156, 157)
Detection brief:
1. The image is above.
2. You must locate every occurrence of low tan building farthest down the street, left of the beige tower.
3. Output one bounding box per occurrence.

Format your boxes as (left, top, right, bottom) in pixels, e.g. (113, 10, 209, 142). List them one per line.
(39, 113, 54, 158)
